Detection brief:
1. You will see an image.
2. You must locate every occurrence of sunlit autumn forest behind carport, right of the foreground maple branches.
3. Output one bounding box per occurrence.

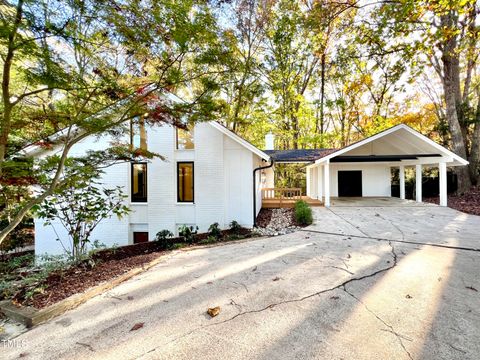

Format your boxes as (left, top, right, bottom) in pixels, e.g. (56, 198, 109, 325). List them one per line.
(213, 0, 480, 191)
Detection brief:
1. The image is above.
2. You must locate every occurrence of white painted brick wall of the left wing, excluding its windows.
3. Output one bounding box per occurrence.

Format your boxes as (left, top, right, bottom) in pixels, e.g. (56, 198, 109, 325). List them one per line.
(35, 123, 265, 254)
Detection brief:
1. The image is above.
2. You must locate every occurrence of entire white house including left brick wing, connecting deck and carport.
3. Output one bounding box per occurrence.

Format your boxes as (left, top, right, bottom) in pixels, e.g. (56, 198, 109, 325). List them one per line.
(31, 122, 468, 254)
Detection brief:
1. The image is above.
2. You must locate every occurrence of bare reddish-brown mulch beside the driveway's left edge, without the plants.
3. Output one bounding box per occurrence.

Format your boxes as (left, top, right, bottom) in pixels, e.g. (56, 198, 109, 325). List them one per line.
(7, 229, 252, 309)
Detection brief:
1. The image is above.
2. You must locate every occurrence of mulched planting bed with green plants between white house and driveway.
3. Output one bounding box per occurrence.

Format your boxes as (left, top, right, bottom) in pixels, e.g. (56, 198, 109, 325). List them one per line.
(0, 229, 256, 309)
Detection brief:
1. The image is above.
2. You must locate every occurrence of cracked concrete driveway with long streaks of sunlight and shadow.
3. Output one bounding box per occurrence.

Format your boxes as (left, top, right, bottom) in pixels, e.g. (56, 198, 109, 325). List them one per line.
(4, 204, 480, 360)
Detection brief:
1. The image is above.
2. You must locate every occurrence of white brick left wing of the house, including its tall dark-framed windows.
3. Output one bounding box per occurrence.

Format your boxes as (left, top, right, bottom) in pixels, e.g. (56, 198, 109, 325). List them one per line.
(35, 122, 270, 254)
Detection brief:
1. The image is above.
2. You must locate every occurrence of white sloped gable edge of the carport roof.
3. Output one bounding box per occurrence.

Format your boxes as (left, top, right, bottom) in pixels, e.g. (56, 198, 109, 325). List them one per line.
(315, 124, 468, 165)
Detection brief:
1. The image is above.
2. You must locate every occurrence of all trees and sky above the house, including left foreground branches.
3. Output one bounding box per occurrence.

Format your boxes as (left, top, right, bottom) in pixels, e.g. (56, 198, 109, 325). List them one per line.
(0, 0, 480, 244)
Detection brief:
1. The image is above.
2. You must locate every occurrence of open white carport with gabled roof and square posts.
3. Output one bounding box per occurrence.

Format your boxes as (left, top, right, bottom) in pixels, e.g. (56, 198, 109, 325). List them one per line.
(307, 124, 468, 207)
